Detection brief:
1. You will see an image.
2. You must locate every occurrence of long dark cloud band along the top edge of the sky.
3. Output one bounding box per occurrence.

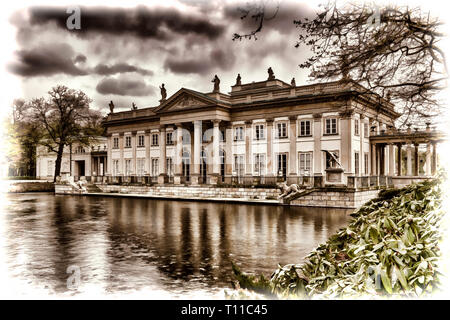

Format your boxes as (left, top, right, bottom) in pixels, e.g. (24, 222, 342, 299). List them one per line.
(25, 6, 225, 40)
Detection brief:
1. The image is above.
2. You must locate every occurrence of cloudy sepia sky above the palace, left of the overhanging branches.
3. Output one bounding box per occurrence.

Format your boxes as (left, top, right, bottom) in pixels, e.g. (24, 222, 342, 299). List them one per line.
(7, 0, 315, 112)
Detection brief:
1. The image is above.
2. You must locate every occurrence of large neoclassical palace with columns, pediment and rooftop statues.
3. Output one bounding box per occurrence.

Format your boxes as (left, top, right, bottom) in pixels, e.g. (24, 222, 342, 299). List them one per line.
(105, 69, 399, 185)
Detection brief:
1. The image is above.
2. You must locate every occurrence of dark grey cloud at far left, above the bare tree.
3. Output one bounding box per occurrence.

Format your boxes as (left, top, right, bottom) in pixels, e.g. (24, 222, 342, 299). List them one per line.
(7, 43, 87, 77)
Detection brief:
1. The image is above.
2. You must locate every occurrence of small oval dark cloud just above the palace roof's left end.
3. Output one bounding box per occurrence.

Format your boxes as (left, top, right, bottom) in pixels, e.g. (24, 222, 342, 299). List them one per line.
(96, 78, 155, 97)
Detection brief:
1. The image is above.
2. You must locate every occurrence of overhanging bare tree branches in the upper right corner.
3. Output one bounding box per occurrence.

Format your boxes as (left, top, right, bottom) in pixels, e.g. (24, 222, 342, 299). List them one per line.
(233, 1, 448, 126)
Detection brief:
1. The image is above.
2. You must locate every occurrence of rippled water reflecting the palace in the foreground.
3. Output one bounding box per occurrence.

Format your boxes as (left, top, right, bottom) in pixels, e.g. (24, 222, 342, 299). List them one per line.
(0, 193, 349, 298)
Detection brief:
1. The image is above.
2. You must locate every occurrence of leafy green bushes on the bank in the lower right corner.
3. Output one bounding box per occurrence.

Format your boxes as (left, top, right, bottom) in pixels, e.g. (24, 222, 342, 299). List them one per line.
(231, 179, 444, 298)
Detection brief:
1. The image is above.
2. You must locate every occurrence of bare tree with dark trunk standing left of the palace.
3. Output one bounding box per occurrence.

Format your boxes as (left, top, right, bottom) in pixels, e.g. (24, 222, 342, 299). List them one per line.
(27, 85, 101, 181)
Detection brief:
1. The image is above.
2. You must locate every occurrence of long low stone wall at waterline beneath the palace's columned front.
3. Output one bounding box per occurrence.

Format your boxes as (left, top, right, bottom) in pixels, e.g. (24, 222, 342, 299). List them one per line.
(55, 184, 280, 200)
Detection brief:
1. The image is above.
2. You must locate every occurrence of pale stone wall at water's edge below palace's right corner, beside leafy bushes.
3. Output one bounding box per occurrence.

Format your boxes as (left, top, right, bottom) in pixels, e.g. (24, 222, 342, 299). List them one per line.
(290, 189, 380, 208)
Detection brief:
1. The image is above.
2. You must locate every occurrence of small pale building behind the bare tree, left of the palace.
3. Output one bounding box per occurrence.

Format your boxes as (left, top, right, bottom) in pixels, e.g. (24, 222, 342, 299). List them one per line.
(36, 137, 107, 179)
